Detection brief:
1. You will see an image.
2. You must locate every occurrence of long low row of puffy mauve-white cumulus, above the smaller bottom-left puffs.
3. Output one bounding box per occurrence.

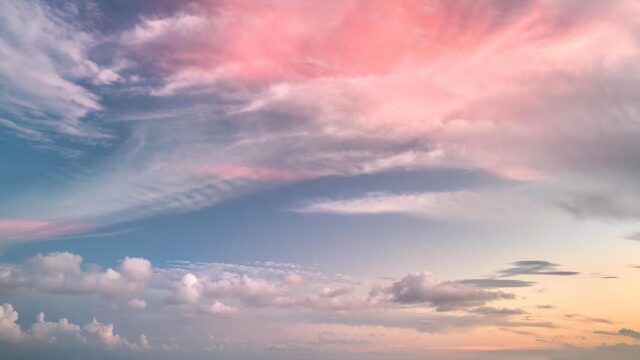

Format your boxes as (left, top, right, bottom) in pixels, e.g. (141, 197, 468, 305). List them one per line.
(0, 252, 524, 315)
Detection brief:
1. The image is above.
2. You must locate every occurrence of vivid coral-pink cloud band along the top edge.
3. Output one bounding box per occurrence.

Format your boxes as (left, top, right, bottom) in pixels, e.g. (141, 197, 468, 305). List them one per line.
(125, 0, 633, 87)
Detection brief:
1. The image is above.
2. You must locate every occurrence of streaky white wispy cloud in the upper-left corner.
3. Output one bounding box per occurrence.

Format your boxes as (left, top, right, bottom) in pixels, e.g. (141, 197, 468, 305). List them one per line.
(0, 1, 119, 140)
